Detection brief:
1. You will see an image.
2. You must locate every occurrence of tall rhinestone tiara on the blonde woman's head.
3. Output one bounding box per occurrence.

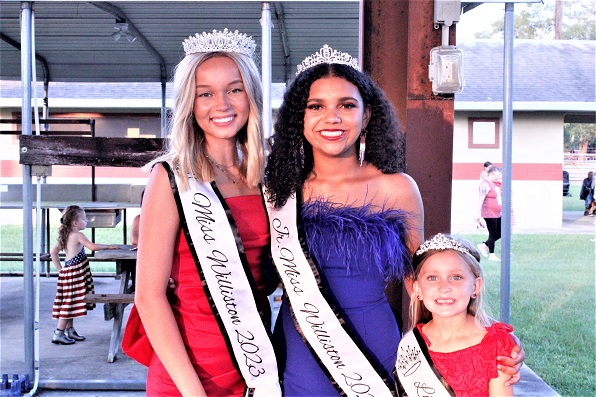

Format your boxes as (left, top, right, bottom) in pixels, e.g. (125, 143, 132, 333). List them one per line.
(182, 29, 257, 57)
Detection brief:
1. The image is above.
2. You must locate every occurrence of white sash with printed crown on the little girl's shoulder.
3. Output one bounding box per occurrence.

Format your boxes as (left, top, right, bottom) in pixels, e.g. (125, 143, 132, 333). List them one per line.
(395, 330, 455, 397)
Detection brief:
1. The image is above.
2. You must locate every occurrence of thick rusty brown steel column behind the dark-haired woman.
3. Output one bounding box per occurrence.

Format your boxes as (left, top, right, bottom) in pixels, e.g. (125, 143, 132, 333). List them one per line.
(363, 0, 454, 236)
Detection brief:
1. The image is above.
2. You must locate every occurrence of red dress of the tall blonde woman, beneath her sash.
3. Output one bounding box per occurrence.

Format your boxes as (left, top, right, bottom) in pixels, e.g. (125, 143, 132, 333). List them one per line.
(147, 195, 269, 396)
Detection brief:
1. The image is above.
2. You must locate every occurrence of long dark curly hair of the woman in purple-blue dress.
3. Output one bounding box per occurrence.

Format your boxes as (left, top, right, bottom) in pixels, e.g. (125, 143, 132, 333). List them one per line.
(265, 64, 405, 208)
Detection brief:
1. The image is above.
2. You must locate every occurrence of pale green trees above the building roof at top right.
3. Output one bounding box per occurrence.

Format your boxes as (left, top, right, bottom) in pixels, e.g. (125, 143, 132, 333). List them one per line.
(476, 0, 596, 40)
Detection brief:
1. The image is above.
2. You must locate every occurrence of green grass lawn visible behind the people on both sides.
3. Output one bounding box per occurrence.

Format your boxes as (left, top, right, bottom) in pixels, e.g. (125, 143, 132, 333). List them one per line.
(0, 224, 596, 396)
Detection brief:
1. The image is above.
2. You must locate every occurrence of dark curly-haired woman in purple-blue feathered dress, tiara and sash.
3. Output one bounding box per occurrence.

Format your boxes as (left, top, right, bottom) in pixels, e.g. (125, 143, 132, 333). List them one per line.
(265, 45, 515, 396)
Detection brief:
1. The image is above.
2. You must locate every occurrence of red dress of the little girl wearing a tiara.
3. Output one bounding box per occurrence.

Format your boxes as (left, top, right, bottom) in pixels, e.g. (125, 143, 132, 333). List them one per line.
(418, 323, 515, 397)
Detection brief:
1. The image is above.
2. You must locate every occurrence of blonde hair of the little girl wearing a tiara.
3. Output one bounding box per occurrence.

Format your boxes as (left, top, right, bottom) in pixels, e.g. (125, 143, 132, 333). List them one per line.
(410, 234, 496, 328)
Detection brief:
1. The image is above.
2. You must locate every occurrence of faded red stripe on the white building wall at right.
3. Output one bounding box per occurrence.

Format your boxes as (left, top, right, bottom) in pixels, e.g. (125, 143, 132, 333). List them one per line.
(453, 163, 563, 181)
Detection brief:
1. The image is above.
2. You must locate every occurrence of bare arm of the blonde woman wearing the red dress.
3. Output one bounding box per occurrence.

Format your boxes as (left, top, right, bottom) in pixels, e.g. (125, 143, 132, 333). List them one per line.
(135, 164, 205, 396)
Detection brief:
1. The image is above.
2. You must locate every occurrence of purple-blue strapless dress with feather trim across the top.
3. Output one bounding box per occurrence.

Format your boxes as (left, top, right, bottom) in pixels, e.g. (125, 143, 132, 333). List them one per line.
(276, 201, 411, 397)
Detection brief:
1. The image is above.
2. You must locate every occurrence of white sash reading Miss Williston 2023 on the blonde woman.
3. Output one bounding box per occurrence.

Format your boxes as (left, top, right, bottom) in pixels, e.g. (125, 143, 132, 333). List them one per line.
(176, 175, 281, 397)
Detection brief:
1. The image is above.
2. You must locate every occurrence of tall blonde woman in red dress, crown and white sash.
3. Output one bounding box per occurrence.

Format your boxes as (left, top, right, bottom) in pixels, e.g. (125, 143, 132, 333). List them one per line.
(135, 29, 280, 396)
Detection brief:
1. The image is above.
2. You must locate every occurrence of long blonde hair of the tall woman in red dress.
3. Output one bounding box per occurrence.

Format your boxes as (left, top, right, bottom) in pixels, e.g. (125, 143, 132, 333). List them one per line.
(144, 52, 265, 190)
